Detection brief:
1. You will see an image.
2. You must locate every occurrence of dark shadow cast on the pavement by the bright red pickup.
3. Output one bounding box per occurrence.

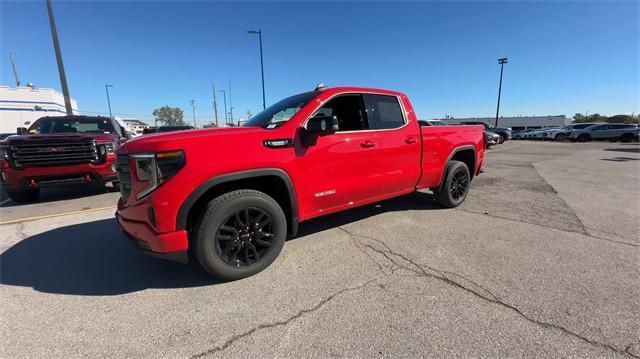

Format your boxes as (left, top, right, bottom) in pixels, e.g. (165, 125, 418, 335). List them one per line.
(0, 193, 440, 296)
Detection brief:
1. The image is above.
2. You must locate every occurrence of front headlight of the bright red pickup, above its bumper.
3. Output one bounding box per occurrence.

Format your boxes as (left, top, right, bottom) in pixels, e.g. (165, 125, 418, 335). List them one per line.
(131, 151, 185, 199)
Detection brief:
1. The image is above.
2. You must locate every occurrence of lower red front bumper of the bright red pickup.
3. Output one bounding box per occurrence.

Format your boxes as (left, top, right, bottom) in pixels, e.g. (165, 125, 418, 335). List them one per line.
(116, 212, 189, 263)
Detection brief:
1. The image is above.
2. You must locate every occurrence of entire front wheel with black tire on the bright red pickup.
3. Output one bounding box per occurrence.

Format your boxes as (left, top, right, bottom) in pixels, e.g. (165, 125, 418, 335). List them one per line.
(194, 189, 287, 280)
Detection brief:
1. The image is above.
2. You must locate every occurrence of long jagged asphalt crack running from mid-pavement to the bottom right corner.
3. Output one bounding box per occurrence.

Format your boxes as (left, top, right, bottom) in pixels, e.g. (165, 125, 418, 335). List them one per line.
(338, 227, 640, 358)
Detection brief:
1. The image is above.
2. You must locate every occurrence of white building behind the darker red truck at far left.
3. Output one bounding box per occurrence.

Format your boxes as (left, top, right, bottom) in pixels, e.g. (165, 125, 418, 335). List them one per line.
(0, 86, 79, 133)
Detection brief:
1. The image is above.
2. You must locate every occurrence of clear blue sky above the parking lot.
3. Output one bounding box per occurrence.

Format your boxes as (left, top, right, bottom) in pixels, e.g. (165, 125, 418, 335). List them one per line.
(0, 0, 640, 123)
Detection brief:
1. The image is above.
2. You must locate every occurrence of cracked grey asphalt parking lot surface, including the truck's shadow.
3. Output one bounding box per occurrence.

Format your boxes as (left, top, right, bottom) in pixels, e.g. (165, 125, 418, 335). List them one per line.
(0, 141, 640, 358)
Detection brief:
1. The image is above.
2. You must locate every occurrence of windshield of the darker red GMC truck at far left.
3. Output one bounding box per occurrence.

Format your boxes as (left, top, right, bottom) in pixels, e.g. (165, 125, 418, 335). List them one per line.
(29, 117, 114, 135)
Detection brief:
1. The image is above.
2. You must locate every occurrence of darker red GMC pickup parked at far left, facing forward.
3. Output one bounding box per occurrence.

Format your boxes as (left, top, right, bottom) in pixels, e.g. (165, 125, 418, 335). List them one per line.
(0, 116, 127, 202)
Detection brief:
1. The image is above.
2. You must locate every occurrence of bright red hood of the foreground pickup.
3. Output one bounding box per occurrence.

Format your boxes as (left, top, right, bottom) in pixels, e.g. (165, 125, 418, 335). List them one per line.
(118, 126, 268, 153)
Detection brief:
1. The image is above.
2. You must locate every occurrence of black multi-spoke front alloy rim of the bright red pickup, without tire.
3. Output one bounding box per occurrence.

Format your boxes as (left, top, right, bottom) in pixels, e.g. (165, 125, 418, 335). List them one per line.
(216, 207, 275, 267)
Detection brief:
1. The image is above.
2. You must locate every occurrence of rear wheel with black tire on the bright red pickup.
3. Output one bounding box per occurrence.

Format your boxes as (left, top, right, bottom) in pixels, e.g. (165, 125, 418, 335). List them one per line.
(433, 161, 471, 208)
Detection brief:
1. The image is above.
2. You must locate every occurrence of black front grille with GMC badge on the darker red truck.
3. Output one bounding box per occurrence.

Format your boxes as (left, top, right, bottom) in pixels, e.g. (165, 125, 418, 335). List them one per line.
(10, 140, 98, 167)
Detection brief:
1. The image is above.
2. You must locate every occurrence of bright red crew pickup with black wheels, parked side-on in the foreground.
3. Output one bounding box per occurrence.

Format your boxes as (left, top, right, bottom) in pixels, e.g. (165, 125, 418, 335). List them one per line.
(116, 87, 484, 280)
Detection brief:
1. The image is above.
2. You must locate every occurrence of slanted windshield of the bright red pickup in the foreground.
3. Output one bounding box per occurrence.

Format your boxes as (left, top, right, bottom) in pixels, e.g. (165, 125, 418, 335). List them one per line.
(243, 91, 318, 129)
